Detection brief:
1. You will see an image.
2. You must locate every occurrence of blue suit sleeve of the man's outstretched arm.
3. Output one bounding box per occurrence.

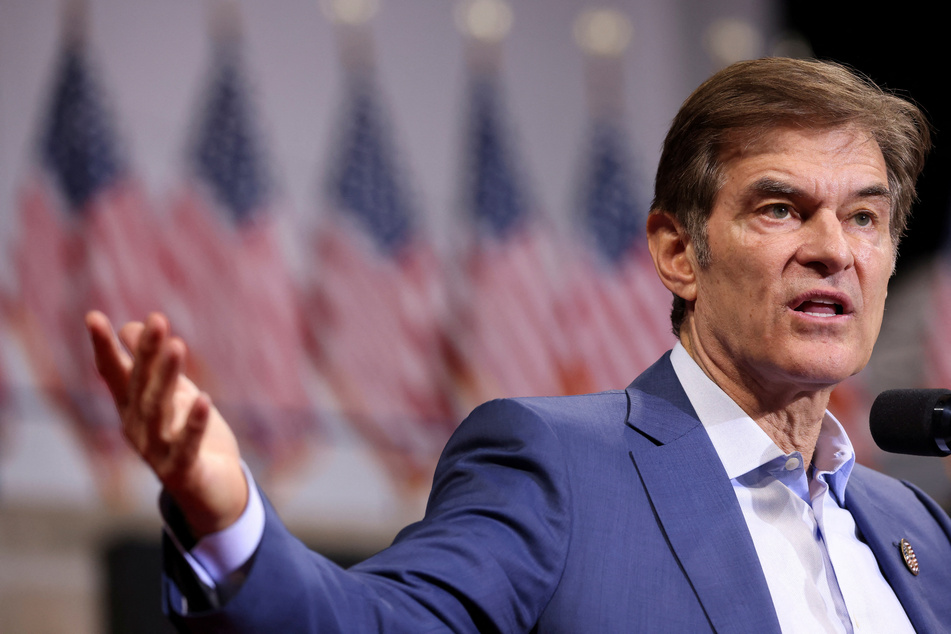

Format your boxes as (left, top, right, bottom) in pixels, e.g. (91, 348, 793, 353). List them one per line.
(165, 400, 571, 633)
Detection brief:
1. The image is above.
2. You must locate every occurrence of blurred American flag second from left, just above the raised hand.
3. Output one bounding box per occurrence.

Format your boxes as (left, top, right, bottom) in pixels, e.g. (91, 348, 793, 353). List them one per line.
(166, 29, 318, 474)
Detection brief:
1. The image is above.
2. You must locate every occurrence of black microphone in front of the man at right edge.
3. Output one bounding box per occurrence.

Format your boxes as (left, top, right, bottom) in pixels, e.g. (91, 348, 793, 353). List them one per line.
(868, 390, 951, 456)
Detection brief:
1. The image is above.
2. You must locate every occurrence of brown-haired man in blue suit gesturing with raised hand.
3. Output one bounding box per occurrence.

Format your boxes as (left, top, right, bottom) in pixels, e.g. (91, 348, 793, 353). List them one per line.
(87, 59, 951, 632)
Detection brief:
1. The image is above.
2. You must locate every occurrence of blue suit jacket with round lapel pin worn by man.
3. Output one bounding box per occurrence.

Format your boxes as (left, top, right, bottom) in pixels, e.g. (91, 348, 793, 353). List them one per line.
(166, 356, 951, 634)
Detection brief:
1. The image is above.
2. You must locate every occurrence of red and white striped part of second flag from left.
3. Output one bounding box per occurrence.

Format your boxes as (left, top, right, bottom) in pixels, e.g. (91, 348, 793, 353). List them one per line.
(163, 185, 317, 468)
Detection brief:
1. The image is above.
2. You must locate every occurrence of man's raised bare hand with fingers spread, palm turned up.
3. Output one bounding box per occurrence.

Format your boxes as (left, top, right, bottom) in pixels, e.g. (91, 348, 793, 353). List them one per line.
(86, 311, 248, 538)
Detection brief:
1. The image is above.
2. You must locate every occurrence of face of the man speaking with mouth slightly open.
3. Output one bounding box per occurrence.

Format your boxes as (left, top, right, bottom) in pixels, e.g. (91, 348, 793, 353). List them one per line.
(688, 128, 894, 392)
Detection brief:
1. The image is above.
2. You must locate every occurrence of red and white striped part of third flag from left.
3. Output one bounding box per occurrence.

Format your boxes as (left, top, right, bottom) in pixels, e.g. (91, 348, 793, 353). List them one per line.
(308, 214, 454, 466)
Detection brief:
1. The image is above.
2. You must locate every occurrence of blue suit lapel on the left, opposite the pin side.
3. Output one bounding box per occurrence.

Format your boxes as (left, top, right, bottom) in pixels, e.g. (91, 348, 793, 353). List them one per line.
(627, 357, 780, 632)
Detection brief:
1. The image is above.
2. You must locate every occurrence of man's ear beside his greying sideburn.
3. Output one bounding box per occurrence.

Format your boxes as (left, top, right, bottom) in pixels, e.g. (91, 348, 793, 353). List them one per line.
(647, 209, 697, 302)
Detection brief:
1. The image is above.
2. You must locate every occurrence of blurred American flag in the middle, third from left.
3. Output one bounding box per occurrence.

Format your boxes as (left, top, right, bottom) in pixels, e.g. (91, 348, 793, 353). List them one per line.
(308, 68, 454, 485)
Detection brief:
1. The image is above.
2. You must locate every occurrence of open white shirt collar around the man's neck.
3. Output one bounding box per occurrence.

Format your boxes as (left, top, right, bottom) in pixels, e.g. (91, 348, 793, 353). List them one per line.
(670, 342, 855, 505)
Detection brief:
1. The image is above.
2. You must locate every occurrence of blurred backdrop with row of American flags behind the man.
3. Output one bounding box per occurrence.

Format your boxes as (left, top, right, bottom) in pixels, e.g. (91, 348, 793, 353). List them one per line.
(0, 0, 951, 633)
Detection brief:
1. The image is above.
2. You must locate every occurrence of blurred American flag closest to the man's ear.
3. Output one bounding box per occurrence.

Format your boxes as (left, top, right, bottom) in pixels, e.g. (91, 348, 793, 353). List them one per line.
(563, 117, 675, 392)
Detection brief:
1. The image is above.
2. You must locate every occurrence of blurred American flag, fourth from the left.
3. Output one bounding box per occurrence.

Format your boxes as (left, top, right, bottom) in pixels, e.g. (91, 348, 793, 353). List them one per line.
(449, 71, 567, 407)
